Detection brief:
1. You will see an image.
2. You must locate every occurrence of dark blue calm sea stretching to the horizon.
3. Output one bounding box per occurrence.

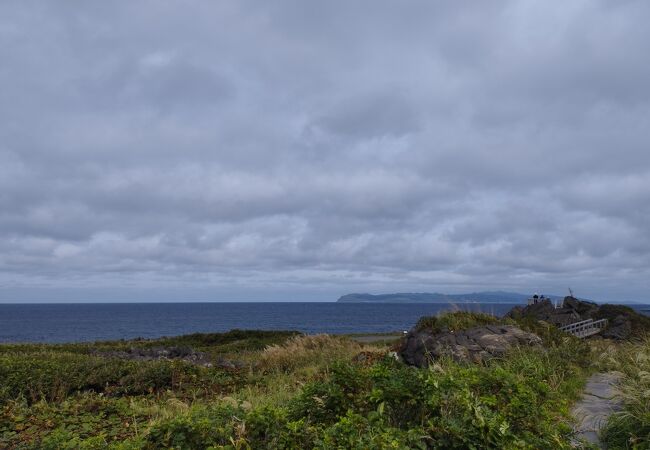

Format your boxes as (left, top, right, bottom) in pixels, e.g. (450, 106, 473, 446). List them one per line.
(0, 303, 650, 342)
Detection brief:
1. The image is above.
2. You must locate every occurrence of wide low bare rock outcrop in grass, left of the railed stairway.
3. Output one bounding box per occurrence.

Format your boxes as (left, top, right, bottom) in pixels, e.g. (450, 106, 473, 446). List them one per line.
(399, 325, 542, 367)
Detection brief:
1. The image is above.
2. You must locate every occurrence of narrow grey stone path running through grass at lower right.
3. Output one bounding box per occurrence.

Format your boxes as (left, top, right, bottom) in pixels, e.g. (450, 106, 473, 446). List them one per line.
(572, 372, 621, 448)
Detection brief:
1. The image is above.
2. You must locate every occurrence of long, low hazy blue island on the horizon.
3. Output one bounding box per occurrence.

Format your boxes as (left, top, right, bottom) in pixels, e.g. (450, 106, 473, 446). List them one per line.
(336, 291, 562, 303)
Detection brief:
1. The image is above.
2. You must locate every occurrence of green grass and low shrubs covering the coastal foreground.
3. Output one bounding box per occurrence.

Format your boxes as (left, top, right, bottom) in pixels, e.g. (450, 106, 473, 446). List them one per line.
(0, 313, 650, 449)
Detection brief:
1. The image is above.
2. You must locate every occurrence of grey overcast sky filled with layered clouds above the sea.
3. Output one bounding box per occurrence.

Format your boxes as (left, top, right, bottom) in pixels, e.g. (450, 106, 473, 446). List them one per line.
(0, 0, 650, 302)
